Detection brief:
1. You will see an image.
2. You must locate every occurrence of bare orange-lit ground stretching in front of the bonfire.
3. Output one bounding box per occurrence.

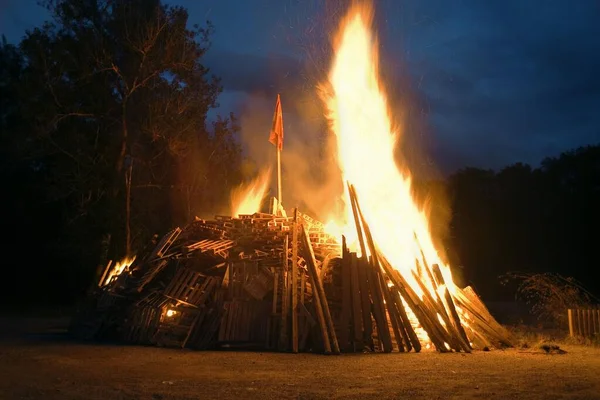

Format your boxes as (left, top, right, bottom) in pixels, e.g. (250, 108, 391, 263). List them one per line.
(0, 317, 600, 400)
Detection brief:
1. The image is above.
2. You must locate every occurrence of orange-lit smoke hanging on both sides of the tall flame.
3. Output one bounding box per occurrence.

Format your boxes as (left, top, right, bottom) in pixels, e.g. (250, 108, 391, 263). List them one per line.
(232, 1, 451, 264)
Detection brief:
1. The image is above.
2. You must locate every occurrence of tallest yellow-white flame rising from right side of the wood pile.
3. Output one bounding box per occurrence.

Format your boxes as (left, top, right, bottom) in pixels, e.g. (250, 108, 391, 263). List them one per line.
(321, 4, 455, 310)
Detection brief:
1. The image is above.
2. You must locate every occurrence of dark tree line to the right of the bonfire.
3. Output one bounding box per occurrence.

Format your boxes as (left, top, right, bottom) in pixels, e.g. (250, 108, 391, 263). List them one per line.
(446, 145, 600, 299)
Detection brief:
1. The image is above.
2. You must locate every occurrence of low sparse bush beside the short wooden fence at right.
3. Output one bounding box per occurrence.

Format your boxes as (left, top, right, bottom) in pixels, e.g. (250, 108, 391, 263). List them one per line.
(503, 272, 597, 327)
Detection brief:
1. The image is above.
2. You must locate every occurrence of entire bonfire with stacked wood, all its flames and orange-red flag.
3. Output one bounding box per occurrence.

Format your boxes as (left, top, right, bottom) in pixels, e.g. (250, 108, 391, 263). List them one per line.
(69, 4, 511, 353)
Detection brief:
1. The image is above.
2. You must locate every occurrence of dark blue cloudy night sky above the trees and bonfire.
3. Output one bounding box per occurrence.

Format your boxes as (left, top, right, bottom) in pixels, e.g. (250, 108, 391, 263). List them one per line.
(0, 0, 600, 171)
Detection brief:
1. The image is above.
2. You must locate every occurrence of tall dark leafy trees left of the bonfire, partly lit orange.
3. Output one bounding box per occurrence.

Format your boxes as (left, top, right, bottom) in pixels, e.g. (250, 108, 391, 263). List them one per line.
(0, 0, 241, 301)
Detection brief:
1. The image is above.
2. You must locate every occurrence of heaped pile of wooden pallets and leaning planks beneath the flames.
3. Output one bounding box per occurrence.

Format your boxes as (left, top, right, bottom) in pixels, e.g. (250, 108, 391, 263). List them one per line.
(72, 186, 511, 354)
